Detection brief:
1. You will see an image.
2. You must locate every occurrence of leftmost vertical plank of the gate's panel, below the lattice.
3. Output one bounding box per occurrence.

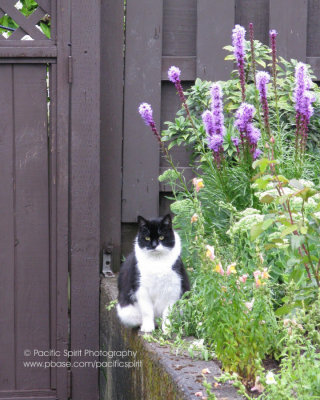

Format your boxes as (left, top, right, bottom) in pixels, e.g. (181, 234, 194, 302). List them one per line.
(0, 65, 15, 390)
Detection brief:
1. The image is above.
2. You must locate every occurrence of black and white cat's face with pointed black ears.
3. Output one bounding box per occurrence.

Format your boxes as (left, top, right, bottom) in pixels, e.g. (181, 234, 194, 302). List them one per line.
(137, 214, 175, 253)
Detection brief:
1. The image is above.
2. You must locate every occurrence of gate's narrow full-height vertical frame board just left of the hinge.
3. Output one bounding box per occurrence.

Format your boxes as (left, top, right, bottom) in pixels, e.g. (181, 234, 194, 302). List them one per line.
(51, 0, 71, 400)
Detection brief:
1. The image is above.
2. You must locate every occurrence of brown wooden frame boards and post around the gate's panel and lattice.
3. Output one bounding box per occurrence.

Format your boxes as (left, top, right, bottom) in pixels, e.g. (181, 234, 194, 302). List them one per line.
(0, 0, 100, 400)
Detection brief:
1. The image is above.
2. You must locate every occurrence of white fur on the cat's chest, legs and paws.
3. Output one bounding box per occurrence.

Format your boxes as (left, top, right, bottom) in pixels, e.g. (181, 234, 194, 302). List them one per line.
(117, 232, 181, 332)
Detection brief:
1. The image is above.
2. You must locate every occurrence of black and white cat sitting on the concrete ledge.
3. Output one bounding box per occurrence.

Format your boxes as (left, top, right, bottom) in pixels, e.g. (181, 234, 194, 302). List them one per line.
(117, 214, 190, 332)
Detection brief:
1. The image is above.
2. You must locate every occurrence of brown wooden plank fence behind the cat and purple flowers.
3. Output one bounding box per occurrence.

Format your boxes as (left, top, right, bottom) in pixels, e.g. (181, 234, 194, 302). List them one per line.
(101, 0, 320, 269)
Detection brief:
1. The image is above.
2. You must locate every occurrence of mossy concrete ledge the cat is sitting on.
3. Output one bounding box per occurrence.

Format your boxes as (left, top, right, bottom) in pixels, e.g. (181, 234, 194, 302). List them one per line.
(100, 278, 243, 400)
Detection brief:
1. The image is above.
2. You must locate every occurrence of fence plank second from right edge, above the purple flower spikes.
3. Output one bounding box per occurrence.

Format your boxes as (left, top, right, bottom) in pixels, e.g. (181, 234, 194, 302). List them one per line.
(270, 0, 308, 62)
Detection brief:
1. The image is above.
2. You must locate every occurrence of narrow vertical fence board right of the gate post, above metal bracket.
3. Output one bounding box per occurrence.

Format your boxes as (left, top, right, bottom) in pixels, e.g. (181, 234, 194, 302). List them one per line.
(100, 0, 124, 271)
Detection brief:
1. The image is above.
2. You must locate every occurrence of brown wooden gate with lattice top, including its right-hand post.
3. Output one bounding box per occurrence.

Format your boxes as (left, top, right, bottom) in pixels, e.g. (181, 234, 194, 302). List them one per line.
(0, 0, 100, 400)
